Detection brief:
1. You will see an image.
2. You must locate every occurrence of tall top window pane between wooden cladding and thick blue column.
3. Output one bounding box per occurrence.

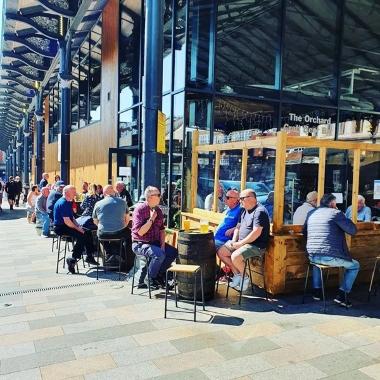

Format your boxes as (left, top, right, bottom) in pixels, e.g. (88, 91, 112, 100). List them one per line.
(119, 0, 142, 111)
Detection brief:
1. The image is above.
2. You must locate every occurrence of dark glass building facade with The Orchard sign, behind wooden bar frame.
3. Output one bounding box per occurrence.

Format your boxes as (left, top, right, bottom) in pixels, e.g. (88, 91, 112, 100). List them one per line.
(119, 0, 380, 226)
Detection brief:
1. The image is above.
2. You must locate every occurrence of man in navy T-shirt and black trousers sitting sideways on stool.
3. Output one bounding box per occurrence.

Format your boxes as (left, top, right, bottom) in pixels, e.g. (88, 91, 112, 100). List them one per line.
(54, 185, 98, 274)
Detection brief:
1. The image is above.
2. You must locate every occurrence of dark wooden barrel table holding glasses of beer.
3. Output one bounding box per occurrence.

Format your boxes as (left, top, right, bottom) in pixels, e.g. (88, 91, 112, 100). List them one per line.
(177, 231, 216, 301)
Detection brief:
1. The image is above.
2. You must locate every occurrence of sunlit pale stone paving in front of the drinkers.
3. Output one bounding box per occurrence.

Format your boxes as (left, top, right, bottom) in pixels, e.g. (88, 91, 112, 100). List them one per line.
(0, 203, 380, 380)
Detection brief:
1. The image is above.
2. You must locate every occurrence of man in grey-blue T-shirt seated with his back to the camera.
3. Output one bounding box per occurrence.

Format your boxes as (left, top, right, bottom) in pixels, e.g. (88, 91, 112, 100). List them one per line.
(92, 185, 133, 270)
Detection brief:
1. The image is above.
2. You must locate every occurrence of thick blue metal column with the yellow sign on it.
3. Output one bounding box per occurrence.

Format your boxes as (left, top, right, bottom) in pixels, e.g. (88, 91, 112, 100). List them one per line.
(141, 0, 163, 189)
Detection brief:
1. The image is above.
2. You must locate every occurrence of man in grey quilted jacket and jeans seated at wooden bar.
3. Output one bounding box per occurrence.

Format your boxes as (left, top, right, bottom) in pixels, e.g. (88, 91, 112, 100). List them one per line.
(303, 194, 360, 307)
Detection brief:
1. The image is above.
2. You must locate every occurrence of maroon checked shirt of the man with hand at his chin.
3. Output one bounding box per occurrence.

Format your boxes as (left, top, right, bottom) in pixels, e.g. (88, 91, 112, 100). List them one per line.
(132, 202, 165, 244)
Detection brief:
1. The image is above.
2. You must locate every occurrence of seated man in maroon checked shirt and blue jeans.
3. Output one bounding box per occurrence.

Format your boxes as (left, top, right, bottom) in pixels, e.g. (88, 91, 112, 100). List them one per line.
(132, 186, 178, 289)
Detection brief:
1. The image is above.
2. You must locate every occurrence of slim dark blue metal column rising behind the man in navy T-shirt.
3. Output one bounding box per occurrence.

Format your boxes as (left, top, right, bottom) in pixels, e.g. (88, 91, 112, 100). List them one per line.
(58, 38, 72, 184)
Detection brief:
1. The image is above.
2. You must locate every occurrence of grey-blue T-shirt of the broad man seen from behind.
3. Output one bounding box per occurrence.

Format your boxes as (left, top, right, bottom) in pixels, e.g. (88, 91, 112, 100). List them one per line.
(92, 197, 129, 232)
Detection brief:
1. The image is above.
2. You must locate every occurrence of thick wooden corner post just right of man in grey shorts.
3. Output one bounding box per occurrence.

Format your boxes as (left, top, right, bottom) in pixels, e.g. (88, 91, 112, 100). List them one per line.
(273, 132, 287, 233)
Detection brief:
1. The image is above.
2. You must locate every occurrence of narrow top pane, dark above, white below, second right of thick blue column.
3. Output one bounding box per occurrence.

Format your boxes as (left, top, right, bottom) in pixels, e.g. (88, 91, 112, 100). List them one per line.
(174, 0, 186, 90)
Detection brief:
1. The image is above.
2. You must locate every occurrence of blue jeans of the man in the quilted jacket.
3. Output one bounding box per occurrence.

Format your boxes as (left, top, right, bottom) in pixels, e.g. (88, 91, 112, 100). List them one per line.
(309, 255, 360, 293)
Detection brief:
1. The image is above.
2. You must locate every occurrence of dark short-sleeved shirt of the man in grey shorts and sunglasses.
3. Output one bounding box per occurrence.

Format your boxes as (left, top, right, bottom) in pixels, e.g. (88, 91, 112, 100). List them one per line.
(239, 204, 270, 248)
